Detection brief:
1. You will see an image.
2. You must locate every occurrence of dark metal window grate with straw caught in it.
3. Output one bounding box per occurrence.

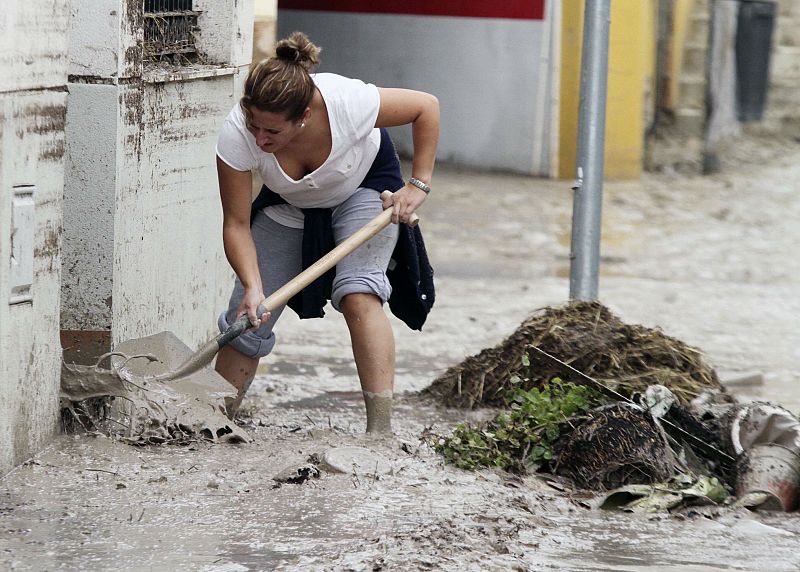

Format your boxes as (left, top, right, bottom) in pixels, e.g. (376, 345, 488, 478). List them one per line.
(144, 0, 200, 64)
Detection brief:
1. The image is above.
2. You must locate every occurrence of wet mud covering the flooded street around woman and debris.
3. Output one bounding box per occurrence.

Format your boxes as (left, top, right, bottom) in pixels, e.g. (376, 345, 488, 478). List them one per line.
(0, 136, 800, 572)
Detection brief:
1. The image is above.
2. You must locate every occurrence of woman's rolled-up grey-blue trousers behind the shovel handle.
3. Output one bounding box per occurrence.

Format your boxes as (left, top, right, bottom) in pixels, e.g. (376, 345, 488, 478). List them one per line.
(217, 188, 398, 357)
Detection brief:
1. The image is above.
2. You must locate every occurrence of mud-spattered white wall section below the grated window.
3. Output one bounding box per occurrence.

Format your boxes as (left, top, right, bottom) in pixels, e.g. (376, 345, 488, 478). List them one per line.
(62, 75, 240, 345)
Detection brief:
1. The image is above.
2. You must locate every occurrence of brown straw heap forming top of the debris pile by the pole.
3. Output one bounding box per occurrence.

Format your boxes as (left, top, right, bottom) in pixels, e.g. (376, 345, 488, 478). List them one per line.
(423, 301, 722, 409)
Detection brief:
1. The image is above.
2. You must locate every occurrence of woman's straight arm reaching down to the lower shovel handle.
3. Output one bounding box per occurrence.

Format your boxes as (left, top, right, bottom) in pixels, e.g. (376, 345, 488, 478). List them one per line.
(217, 157, 264, 325)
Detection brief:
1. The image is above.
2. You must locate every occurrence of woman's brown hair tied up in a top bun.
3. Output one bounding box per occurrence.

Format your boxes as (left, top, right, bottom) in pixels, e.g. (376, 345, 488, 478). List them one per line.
(239, 32, 322, 121)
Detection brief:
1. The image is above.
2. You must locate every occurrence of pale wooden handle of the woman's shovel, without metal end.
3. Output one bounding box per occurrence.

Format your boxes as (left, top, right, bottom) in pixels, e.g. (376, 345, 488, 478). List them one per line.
(255, 191, 419, 319)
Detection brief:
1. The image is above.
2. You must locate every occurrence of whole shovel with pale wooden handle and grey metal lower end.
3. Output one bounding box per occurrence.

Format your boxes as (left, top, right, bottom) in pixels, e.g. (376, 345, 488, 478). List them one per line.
(134, 191, 419, 382)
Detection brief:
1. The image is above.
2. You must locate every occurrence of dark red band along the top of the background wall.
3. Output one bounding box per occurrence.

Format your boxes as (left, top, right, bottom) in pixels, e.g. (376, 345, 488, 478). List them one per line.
(278, 0, 545, 20)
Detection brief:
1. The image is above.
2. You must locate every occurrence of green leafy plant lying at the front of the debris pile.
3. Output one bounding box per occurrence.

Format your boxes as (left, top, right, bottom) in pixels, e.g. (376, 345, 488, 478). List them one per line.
(432, 370, 601, 472)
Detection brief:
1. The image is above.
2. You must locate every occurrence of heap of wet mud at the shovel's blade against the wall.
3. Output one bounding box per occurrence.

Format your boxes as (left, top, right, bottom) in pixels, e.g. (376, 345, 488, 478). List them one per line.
(61, 332, 250, 445)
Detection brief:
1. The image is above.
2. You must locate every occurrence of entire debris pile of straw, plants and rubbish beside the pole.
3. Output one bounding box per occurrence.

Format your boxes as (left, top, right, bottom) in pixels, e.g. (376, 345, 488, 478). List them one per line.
(423, 302, 800, 511)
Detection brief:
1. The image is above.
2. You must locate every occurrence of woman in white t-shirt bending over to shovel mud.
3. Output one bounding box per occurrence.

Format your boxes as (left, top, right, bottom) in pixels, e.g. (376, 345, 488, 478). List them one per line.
(216, 32, 439, 432)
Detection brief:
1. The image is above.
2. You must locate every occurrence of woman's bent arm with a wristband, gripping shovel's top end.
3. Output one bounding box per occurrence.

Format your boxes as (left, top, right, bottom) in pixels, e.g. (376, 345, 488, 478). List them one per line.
(375, 88, 439, 222)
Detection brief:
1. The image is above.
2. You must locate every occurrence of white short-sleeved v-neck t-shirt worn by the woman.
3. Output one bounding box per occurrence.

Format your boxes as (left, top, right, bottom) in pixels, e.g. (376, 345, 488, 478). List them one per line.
(217, 73, 381, 228)
